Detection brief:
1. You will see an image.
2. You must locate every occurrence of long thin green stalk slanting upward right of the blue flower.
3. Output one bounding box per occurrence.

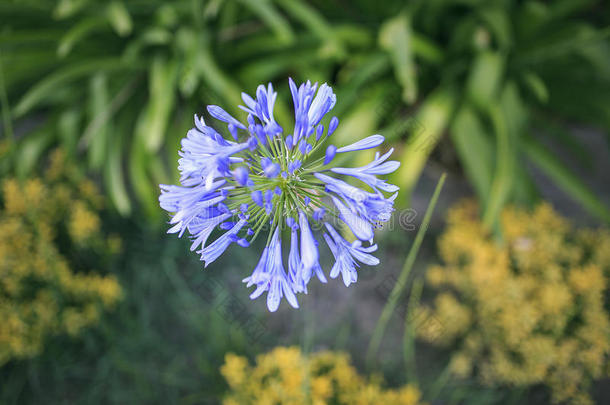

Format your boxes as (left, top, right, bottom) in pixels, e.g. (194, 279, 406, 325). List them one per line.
(366, 173, 447, 368)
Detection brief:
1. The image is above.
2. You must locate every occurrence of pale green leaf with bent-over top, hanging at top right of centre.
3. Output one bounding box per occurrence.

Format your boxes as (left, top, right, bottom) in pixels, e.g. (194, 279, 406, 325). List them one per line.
(379, 14, 417, 104)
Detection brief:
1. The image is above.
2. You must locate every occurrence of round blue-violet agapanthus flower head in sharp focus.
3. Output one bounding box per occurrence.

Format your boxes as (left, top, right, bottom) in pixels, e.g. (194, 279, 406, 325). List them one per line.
(159, 79, 400, 311)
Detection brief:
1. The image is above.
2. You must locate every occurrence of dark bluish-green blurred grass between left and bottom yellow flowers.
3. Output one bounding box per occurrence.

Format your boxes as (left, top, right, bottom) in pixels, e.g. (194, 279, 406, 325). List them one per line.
(0, 216, 268, 404)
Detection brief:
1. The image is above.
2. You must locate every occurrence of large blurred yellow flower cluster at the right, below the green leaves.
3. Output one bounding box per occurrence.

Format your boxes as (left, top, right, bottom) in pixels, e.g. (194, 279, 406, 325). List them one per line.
(418, 201, 610, 404)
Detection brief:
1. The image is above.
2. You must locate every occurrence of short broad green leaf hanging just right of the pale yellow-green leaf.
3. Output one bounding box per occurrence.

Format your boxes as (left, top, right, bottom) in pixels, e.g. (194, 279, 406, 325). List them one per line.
(451, 105, 495, 205)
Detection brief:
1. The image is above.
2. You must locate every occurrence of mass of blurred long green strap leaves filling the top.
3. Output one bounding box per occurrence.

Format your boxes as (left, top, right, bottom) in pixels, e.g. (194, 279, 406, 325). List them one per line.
(0, 0, 610, 223)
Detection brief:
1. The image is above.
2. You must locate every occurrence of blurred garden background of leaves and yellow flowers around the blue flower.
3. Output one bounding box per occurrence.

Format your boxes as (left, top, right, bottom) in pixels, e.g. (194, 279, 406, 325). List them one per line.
(0, 0, 610, 404)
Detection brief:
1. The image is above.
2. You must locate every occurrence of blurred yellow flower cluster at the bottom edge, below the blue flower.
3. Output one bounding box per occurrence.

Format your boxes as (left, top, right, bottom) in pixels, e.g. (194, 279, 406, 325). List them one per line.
(220, 347, 421, 405)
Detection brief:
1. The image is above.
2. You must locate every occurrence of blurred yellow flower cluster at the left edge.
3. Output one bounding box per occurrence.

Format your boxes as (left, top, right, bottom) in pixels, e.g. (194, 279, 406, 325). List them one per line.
(0, 151, 122, 365)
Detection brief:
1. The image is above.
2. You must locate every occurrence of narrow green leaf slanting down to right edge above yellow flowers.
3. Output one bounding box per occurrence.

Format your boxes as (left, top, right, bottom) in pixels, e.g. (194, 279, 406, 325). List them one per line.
(524, 138, 610, 222)
